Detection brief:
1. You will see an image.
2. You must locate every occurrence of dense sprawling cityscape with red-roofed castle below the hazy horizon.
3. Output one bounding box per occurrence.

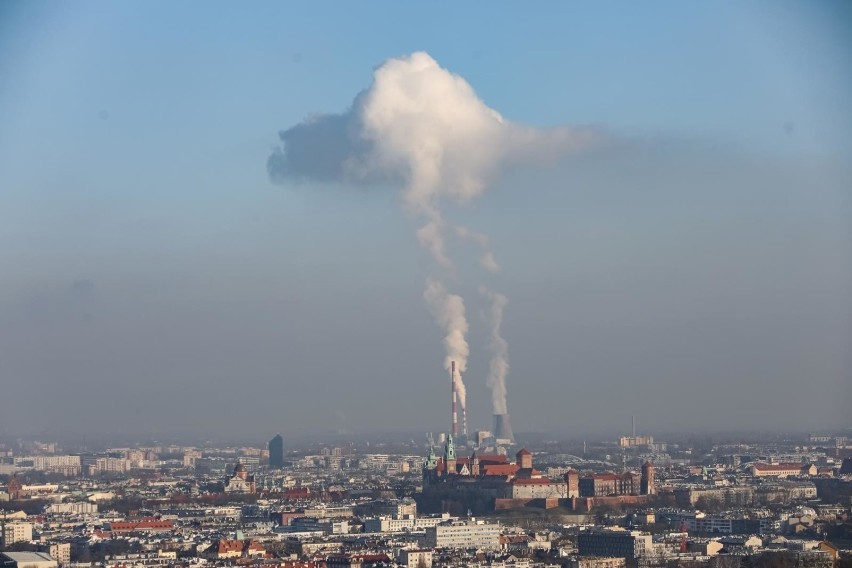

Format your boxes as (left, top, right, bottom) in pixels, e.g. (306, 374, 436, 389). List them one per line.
(0, 429, 852, 568)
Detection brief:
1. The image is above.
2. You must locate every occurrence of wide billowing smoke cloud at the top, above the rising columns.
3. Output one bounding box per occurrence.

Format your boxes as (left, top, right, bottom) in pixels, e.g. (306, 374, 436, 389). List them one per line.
(267, 52, 604, 190)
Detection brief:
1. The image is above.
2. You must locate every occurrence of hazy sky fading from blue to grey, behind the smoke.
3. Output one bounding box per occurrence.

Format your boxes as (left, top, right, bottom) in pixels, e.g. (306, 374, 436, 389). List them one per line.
(0, 0, 852, 440)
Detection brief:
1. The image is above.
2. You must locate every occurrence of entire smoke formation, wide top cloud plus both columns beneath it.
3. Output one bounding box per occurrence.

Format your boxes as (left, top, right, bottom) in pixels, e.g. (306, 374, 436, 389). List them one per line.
(267, 52, 601, 426)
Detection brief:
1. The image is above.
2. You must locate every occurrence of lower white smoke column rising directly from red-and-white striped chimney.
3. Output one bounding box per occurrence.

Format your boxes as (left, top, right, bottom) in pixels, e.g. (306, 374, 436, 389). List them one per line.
(423, 278, 470, 408)
